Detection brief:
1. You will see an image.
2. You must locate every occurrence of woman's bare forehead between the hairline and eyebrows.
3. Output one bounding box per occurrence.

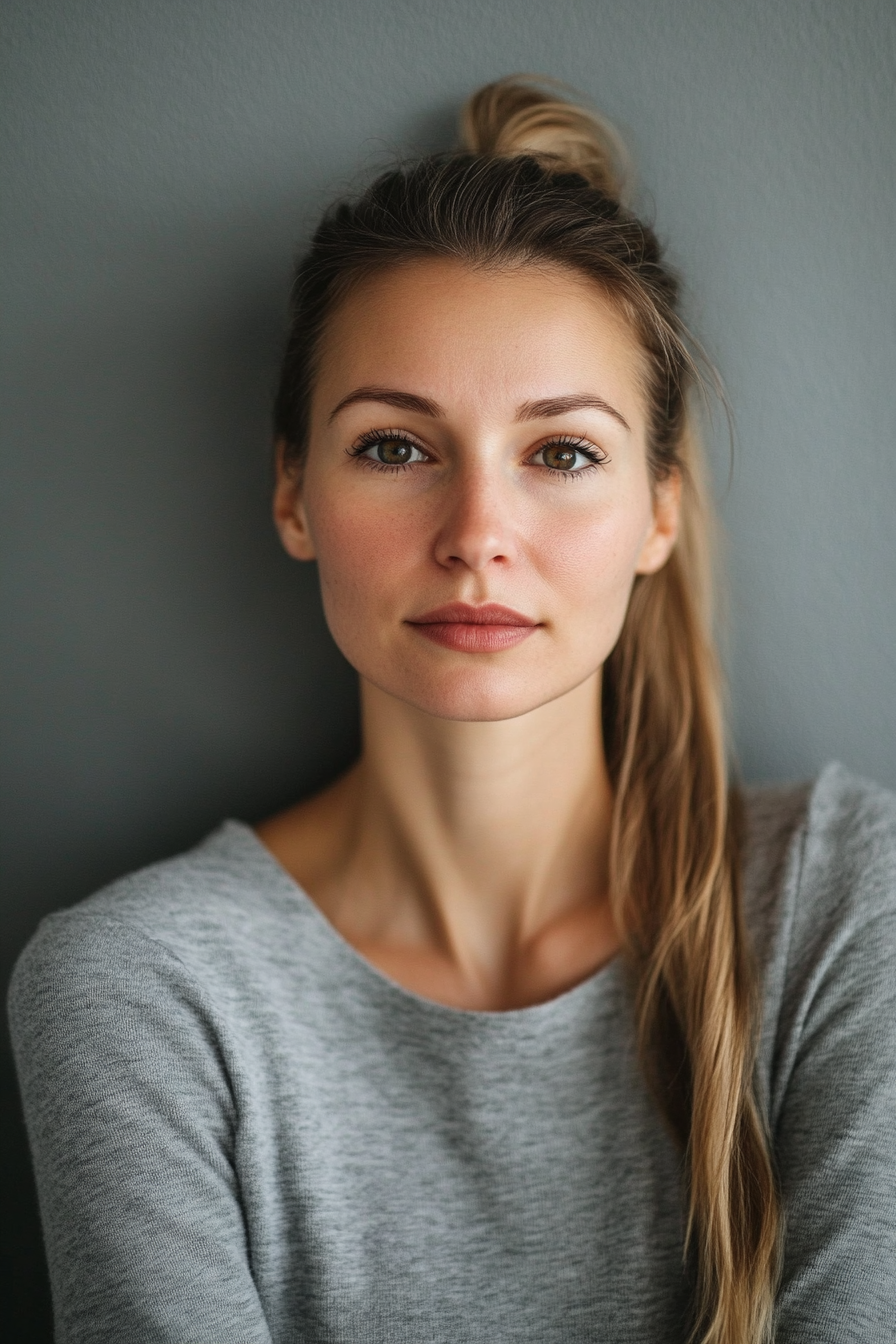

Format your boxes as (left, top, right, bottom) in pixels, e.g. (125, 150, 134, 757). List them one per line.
(314, 259, 645, 423)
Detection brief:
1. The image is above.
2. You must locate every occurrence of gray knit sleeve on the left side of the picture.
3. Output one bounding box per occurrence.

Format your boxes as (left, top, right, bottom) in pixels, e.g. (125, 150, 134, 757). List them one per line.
(9, 913, 271, 1344)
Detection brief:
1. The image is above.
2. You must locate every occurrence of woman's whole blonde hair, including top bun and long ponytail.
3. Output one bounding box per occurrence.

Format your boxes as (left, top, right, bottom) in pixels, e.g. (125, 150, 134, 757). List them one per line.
(275, 77, 780, 1344)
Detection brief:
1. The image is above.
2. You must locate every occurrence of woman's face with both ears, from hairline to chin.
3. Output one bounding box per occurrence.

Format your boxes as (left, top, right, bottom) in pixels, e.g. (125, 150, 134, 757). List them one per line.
(275, 261, 678, 720)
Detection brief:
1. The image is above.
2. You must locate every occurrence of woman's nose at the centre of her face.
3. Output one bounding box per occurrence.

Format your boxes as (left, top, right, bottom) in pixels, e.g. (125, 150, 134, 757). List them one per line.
(435, 466, 516, 573)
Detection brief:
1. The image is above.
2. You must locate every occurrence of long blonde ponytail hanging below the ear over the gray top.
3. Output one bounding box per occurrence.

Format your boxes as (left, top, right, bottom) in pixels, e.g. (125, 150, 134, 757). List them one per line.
(603, 416, 780, 1344)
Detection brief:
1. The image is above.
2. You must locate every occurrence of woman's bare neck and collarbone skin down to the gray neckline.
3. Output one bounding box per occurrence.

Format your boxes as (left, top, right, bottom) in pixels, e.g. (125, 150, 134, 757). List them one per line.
(253, 672, 619, 1011)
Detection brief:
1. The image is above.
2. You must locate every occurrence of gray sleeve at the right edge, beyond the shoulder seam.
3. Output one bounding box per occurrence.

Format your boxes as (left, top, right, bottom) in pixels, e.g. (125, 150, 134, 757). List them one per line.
(774, 792, 896, 1344)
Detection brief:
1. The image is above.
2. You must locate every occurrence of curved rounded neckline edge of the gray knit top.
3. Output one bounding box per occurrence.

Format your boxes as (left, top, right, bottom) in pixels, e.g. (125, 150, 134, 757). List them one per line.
(217, 817, 623, 1025)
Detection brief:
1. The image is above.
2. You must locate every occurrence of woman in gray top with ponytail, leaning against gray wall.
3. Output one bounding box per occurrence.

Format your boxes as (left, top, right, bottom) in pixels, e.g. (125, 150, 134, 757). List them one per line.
(12, 81, 896, 1344)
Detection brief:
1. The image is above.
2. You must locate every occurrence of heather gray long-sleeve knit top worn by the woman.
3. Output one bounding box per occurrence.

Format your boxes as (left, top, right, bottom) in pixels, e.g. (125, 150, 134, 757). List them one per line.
(11, 767, 896, 1344)
